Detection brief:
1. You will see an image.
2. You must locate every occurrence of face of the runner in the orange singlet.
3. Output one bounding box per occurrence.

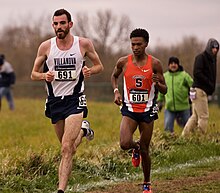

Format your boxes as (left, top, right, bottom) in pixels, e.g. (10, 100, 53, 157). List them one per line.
(131, 37, 148, 56)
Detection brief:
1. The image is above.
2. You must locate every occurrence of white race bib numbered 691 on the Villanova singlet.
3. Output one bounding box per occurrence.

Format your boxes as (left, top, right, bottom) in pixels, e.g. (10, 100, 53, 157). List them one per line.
(55, 65, 76, 81)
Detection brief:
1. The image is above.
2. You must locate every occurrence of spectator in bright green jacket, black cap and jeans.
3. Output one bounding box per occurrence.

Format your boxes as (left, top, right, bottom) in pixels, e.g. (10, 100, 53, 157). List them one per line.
(158, 56, 193, 134)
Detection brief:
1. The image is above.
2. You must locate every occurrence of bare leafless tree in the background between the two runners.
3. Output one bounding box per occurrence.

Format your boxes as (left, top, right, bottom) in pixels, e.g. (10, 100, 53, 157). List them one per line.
(74, 10, 132, 82)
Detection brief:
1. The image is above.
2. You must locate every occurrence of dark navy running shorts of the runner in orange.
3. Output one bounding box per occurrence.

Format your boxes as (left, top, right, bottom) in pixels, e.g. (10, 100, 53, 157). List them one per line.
(121, 105, 158, 123)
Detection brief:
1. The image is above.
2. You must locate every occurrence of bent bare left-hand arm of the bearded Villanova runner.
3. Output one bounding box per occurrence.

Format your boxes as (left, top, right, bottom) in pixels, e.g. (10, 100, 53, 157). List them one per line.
(31, 40, 54, 82)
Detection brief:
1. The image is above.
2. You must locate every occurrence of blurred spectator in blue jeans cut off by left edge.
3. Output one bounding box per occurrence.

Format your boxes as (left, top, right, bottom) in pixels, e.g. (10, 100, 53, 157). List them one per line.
(0, 54, 15, 110)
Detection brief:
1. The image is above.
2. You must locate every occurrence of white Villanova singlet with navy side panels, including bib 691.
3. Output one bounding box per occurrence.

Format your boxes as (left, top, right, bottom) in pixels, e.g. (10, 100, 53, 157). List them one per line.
(44, 36, 85, 97)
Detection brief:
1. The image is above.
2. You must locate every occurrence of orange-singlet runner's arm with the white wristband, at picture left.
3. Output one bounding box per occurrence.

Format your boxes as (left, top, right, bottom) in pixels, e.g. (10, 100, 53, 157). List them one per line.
(111, 57, 127, 105)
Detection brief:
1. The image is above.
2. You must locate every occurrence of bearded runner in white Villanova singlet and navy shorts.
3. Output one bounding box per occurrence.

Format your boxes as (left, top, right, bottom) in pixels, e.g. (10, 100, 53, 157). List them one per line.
(31, 9, 103, 193)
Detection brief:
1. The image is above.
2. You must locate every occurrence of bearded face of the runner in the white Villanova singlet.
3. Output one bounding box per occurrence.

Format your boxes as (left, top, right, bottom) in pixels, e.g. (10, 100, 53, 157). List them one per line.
(52, 14, 73, 39)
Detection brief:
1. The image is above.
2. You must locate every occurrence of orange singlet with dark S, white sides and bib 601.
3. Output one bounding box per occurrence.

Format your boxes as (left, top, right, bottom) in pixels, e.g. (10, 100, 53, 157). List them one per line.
(123, 55, 156, 113)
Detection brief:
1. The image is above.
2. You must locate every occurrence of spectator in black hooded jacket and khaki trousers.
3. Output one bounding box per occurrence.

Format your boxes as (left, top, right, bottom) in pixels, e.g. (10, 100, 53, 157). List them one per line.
(182, 38, 219, 136)
